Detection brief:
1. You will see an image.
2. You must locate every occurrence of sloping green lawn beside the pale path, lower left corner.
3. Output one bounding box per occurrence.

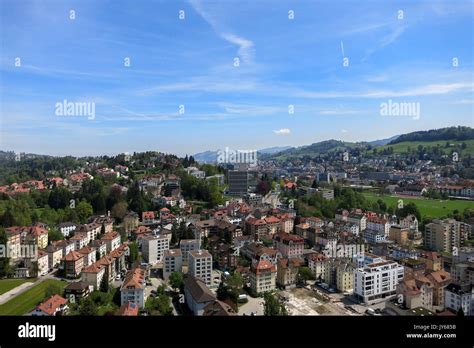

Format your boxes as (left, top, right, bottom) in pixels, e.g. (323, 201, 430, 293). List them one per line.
(0, 279, 67, 315)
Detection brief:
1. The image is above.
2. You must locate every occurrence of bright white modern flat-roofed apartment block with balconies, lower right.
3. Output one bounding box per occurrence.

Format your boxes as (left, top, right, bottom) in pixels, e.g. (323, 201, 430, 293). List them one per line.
(354, 261, 404, 303)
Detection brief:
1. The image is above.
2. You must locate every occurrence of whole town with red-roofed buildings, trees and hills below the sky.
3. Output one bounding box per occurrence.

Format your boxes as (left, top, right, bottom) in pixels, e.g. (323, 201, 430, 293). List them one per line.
(0, 127, 474, 316)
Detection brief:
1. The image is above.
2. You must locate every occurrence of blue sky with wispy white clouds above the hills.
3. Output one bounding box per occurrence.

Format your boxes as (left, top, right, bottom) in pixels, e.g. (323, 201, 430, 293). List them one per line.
(0, 0, 474, 156)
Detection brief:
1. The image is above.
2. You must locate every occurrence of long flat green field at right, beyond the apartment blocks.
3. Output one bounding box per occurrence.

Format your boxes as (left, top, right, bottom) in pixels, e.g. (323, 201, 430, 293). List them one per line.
(364, 192, 474, 218)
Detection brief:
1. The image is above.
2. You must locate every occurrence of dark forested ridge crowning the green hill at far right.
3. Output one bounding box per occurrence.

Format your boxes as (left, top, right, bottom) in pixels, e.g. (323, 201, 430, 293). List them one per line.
(388, 126, 474, 145)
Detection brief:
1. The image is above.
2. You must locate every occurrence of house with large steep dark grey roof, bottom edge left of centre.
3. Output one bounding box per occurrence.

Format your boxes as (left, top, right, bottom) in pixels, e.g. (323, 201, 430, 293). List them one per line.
(184, 275, 216, 315)
